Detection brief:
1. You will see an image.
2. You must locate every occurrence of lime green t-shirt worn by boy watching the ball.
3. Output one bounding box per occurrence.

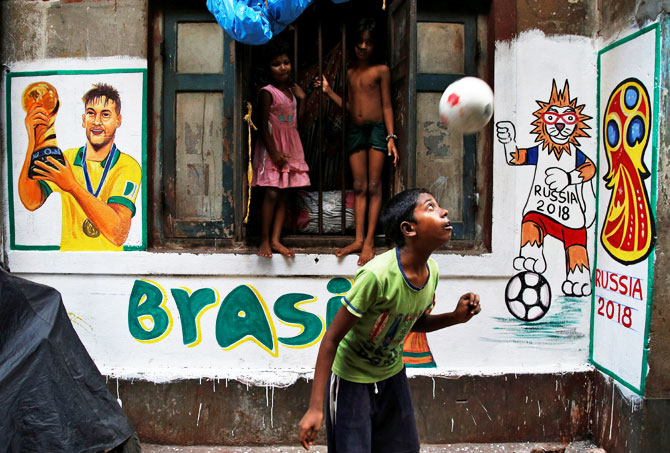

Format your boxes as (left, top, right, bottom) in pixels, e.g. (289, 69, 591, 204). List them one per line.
(332, 248, 438, 384)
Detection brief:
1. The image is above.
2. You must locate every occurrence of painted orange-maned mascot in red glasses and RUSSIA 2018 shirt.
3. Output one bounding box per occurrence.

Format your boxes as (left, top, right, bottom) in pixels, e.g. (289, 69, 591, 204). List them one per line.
(496, 80, 596, 296)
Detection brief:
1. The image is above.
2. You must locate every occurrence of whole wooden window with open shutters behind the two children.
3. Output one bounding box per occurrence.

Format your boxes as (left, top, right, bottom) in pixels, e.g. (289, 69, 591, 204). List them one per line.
(152, 0, 493, 253)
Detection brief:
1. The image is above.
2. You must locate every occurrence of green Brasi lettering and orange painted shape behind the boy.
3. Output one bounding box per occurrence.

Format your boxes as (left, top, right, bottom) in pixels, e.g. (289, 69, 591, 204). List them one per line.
(128, 277, 437, 368)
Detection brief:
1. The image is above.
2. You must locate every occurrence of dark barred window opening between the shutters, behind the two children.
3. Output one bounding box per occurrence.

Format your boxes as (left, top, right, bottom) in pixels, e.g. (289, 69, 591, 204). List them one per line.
(247, 1, 392, 247)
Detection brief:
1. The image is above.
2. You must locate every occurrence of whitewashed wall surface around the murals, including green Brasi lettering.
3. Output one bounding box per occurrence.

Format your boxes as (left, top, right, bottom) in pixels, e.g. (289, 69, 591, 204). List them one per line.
(5, 42, 604, 386)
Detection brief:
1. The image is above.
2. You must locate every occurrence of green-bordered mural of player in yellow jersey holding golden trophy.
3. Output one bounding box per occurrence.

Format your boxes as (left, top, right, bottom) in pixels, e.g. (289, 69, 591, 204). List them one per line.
(7, 69, 146, 251)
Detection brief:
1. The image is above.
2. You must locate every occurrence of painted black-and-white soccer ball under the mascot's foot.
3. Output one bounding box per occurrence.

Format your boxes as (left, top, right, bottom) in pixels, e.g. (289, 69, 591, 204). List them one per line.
(505, 271, 551, 321)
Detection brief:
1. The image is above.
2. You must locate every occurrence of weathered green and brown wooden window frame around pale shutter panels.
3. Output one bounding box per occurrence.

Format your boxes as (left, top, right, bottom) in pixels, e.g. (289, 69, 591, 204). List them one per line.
(149, 0, 500, 254)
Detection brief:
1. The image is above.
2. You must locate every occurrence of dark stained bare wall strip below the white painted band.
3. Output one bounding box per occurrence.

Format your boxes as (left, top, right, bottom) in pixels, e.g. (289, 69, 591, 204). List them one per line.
(108, 371, 594, 444)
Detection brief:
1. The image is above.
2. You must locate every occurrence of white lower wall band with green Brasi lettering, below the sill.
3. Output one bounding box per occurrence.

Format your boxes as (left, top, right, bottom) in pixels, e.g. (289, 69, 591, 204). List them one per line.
(29, 270, 588, 385)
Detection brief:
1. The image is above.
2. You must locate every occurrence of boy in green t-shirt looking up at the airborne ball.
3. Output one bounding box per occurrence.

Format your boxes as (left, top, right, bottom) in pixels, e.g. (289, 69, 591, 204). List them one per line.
(300, 189, 481, 453)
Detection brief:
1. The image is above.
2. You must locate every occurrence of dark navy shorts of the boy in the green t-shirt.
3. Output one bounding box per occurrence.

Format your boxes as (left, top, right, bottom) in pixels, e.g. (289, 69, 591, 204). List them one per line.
(326, 368, 420, 453)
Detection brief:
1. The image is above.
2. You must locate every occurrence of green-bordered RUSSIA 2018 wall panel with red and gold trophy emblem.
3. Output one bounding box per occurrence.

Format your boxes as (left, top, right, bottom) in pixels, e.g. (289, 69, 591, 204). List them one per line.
(591, 24, 660, 394)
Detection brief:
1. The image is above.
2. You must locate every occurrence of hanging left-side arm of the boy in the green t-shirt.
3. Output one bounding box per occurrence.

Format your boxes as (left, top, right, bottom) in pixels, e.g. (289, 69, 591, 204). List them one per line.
(299, 306, 358, 450)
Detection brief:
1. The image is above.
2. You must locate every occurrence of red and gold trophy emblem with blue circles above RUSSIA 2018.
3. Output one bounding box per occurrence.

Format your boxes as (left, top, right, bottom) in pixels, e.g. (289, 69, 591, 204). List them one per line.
(600, 78, 656, 264)
